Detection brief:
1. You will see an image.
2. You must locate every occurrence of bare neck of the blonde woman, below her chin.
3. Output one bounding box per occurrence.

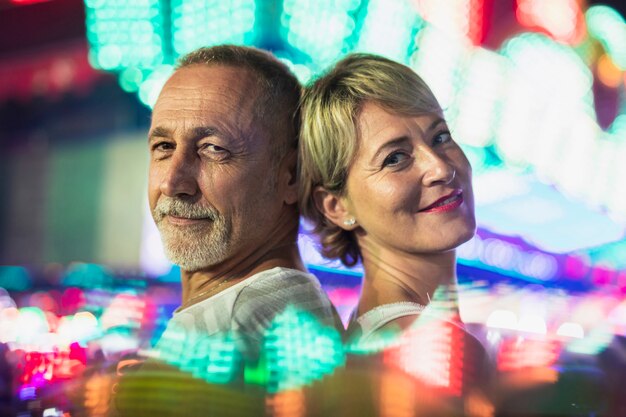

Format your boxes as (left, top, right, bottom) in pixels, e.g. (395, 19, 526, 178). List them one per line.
(358, 243, 456, 316)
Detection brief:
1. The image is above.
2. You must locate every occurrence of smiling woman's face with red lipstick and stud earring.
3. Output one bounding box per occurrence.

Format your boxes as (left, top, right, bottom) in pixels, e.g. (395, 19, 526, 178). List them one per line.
(345, 102, 476, 253)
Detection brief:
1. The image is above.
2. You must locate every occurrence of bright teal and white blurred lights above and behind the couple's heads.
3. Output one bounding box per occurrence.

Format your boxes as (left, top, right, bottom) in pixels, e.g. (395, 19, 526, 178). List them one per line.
(79, 0, 626, 228)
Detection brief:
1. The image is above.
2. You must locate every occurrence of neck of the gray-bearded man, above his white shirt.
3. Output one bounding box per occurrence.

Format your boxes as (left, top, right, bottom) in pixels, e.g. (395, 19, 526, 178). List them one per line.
(181, 216, 306, 306)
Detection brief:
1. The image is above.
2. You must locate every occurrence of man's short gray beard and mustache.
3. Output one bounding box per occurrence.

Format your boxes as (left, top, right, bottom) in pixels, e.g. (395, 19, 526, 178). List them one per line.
(152, 197, 232, 271)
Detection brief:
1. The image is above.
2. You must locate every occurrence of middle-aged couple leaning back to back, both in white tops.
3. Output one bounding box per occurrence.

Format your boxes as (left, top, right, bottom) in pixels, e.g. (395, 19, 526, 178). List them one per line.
(149, 45, 475, 368)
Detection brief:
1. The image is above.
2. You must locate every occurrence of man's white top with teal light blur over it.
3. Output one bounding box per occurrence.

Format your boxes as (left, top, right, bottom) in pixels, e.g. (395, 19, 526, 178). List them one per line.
(155, 267, 336, 369)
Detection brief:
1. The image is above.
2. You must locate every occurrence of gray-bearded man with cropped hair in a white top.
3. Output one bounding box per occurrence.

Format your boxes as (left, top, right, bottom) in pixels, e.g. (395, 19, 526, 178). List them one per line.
(149, 45, 335, 360)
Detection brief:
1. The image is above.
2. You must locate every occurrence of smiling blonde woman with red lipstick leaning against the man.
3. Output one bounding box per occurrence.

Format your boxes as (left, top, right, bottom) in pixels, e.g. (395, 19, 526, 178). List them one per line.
(300, 54, 476, 340)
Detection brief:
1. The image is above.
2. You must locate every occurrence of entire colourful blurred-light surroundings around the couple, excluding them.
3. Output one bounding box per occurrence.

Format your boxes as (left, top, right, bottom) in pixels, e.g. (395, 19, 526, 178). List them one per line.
(0, 0, 626, 416)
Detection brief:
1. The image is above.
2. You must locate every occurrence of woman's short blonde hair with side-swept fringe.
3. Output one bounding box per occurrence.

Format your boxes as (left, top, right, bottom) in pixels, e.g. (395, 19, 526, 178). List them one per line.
(299, 54, 441, 266)
